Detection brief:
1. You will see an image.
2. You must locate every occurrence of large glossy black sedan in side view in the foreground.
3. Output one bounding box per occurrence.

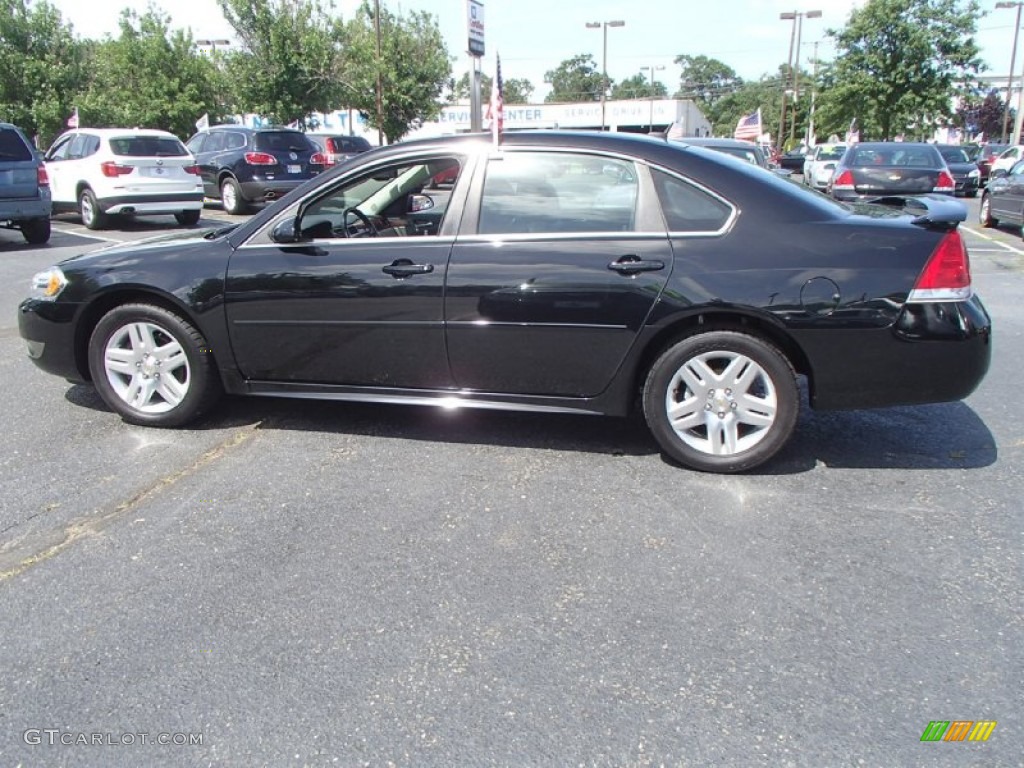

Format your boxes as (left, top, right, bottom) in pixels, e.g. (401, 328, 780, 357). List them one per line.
(18, 131, 991, 472)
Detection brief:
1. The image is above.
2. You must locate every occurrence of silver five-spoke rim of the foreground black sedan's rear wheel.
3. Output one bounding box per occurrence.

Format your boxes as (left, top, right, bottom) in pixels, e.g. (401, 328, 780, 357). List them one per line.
(665, 350, 778, 456)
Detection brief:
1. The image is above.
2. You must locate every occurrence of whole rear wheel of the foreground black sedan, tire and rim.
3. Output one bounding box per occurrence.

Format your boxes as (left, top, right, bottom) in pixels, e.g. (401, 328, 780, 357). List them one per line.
(643, 330, 800, 473)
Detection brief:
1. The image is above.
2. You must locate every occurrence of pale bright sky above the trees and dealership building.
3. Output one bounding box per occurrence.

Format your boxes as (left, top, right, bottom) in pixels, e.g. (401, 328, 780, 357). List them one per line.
(50, 0, 1024, 101)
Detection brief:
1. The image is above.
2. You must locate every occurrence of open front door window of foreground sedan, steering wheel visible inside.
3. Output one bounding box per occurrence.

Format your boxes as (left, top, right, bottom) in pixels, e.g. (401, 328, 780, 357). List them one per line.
(298, 157, 462, 240)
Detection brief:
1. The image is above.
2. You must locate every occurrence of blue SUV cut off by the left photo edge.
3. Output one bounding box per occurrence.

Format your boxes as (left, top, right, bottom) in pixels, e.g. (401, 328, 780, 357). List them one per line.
(0, 123, 53, 245)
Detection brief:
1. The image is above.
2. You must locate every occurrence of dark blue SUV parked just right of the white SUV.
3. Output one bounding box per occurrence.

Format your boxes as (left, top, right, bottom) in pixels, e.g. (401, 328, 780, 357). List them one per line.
(186, 125, 327, 214)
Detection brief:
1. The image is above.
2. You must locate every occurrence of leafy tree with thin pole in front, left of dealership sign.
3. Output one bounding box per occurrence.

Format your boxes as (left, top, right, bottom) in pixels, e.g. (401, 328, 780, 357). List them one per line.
(343, 2, 452, 142)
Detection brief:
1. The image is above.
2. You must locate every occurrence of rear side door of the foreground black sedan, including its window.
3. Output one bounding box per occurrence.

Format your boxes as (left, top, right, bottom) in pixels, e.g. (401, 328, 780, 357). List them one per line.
(444, 148, 672, 397)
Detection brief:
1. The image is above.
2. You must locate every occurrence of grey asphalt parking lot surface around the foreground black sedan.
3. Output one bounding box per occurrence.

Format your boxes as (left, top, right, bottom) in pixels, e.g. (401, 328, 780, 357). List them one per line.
(0, 201, 1024, 767)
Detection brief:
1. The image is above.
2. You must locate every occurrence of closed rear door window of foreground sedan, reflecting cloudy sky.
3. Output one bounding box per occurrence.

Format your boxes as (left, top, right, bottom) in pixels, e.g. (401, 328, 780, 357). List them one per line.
(478, 152, 638, 234)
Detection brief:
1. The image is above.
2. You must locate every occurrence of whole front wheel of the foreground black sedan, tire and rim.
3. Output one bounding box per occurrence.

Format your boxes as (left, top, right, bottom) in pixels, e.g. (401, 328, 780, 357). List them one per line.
(89, 304, 223, 427)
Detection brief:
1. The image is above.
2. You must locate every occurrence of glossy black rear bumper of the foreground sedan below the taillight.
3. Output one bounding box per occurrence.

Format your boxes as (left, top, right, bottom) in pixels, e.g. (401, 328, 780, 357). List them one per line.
(795, 296, 992, 411)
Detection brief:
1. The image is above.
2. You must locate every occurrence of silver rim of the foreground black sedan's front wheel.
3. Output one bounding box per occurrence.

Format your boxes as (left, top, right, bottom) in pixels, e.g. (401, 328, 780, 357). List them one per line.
(103, 322, 191, 414)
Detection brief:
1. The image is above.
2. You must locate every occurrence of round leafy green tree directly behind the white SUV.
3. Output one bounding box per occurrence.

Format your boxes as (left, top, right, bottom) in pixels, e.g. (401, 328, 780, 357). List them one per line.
(78, 6, 225, 138)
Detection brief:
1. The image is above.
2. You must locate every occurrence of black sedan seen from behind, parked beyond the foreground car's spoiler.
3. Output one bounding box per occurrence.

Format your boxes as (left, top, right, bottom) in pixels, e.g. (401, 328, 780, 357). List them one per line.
(828, 141, 956, 202)
